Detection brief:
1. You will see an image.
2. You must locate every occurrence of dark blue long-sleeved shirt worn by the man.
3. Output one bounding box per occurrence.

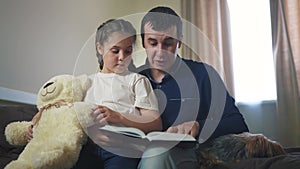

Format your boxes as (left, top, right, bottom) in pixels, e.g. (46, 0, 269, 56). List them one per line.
(138, 57, 249, 141)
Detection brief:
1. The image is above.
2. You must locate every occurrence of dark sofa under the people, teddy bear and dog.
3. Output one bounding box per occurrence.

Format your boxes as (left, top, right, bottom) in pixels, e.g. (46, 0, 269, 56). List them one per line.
(0, 105, 300, 169)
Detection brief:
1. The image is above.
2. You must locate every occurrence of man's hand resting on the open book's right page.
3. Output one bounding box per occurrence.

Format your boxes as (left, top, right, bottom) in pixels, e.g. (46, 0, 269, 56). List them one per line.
(167, 121, 200, 137)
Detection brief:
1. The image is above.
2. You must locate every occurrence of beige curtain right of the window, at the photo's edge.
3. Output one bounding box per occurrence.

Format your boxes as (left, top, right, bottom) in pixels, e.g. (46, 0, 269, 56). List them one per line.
(270, 0, 300, 146)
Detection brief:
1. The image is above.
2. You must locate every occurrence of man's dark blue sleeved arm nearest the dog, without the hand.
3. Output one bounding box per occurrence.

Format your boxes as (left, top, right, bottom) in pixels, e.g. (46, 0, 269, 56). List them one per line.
(197, 66, 249, 141)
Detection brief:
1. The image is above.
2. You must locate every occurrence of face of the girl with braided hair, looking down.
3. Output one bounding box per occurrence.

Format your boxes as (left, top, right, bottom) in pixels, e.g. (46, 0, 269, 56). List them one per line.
(96, 32, 134, 73)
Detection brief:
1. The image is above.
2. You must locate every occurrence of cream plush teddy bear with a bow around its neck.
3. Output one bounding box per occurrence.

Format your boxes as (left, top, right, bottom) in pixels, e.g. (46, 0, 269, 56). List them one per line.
(5, 75, 94, 169)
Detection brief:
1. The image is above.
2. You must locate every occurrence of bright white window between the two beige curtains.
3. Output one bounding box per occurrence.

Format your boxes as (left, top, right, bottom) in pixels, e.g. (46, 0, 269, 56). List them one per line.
(228, 0, 276, 102)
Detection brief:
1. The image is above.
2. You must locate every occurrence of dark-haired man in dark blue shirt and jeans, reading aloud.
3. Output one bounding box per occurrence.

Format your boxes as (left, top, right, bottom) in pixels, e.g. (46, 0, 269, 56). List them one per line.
(138, 7, 249, 169)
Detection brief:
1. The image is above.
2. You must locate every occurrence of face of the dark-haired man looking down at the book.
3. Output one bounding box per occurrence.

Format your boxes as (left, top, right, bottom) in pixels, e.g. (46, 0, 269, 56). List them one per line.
(144, 23, 181, 72)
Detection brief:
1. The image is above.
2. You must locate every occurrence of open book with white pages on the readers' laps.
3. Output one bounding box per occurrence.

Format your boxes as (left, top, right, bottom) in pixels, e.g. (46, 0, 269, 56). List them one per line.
(99, 125, 197, 143)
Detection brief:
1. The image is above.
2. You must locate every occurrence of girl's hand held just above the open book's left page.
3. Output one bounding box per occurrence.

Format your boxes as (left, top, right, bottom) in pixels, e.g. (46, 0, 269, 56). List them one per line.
(92, 106, 124, 125)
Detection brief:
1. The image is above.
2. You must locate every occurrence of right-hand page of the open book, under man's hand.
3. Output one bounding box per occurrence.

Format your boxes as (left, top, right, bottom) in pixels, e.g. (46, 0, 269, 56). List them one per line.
(146, 132, 196, 142)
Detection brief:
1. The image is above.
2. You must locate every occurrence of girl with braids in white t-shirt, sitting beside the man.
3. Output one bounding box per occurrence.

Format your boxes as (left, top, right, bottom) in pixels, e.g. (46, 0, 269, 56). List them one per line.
(85, 19, 162, 169)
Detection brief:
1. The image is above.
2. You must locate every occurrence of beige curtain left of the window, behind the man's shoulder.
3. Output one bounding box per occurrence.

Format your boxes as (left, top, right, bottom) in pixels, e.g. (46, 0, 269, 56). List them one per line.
(181, 0, 234, 96)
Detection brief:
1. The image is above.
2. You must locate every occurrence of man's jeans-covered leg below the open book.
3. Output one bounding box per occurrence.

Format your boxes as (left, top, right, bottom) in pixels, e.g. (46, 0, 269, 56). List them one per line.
(138, 146, 200, 169)
